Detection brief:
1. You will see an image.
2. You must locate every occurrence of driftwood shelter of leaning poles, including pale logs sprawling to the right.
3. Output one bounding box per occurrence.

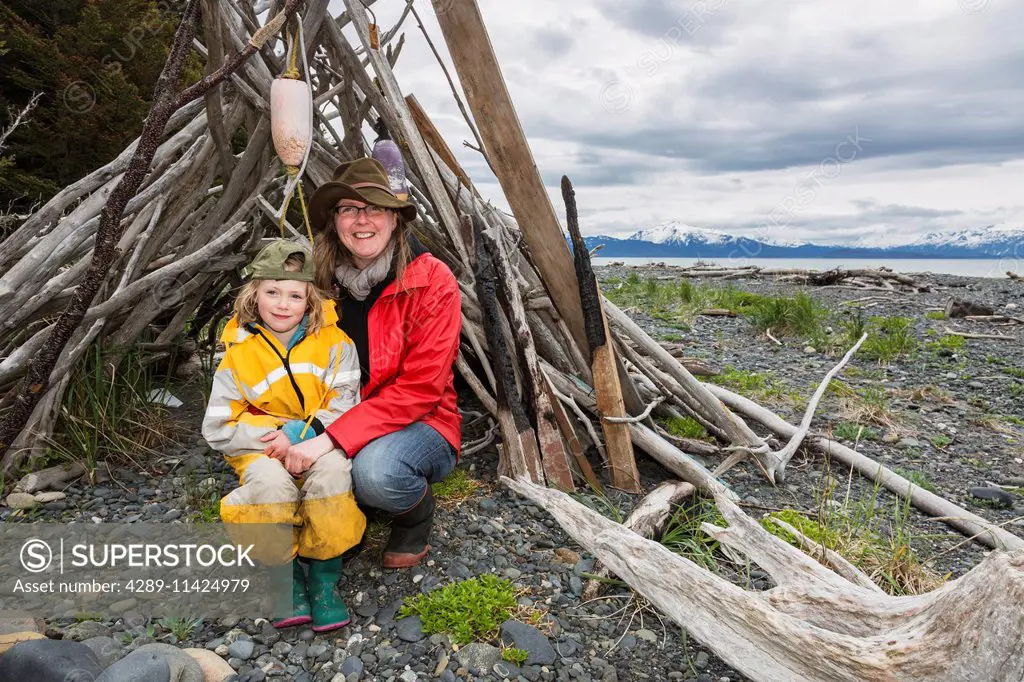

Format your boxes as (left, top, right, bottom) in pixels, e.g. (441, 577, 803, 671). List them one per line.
(0, 0, 1024, 682)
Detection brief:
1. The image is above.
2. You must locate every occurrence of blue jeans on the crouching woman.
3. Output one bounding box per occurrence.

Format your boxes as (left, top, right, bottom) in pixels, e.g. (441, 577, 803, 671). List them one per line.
(352, 422, 455, 514)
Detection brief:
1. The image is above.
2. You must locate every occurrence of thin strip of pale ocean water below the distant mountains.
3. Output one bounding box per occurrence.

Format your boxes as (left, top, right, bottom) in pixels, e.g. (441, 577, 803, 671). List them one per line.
(591, 256, 1024, 278)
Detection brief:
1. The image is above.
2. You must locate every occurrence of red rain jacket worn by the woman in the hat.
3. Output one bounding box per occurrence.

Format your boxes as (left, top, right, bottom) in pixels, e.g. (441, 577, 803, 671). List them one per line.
(327, 253, 462, 458)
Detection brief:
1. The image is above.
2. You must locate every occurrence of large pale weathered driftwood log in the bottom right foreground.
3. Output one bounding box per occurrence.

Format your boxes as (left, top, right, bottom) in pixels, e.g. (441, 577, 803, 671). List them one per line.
(502, 478, 1024, 682)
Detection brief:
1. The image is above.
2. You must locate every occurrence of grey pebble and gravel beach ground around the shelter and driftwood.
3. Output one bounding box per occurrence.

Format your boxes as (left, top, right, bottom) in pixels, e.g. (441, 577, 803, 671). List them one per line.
(0, 266, 1024, 682)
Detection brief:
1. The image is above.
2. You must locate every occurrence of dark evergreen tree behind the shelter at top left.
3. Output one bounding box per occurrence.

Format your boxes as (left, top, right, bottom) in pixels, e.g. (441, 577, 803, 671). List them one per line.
(0, 0, 202, 210)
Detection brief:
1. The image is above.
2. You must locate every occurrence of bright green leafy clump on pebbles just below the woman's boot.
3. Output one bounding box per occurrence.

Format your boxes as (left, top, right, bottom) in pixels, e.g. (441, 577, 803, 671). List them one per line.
(398, 573, 516, 645)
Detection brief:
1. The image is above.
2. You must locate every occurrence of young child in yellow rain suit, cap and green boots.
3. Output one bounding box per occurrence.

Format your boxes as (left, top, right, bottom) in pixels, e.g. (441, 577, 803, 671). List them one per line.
(203, 240, 367, 632)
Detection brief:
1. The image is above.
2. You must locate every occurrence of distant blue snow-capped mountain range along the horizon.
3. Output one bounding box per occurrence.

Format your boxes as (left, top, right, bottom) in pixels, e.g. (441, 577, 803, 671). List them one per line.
(584, 220, 1024, 258)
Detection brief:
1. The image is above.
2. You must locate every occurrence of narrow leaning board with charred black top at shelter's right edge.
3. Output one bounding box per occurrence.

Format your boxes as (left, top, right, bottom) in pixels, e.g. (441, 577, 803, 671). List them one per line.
(562, 175, 640, 493)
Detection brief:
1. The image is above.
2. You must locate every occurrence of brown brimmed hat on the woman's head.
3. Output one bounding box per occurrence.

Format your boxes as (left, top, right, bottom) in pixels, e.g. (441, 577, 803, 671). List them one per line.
(309, 157, 416, 229)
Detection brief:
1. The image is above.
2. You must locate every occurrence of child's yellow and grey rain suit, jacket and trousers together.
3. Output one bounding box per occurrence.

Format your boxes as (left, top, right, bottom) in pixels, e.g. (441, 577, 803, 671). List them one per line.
(203, 301, 366, 563)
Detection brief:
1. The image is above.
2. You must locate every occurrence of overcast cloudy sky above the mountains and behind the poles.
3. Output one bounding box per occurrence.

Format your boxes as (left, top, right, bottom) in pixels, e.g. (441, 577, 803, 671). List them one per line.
(332, 0, 1024, 243)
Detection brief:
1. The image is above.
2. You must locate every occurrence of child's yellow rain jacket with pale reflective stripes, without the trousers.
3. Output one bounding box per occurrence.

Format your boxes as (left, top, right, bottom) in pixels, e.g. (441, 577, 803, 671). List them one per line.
(203, 301, 359, 456)
